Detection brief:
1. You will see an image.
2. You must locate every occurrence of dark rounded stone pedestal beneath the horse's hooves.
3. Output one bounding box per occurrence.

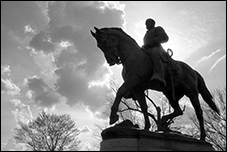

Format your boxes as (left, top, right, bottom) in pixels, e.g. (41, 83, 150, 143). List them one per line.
(100, 126, 214, 151)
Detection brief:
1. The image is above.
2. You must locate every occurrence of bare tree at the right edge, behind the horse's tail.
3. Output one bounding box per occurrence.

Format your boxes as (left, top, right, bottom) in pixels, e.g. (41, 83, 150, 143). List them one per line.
(189, 88, 226, 151)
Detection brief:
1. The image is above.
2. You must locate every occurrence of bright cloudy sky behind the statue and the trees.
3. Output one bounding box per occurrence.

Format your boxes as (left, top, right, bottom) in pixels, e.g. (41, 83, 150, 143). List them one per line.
(1, 1, 226, 150)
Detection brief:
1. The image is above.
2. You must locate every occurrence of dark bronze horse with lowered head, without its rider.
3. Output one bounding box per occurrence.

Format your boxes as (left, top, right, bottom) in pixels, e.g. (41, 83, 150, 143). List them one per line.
(91, 27, 219, 141)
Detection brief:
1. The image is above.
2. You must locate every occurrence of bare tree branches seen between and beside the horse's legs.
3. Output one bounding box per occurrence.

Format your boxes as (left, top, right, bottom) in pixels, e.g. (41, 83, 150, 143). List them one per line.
(105, 81, 185, 131)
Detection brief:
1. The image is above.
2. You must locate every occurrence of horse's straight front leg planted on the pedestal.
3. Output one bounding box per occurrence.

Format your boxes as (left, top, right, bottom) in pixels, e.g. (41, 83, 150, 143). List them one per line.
(136, 92, 151, 130)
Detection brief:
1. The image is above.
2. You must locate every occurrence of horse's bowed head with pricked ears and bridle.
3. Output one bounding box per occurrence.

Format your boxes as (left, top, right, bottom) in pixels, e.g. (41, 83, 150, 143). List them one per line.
(90, 27, 121, 66)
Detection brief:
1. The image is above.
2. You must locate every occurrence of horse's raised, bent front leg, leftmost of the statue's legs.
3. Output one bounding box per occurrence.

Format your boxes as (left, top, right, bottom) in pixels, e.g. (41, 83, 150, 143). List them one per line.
(109, 76, 140, 125)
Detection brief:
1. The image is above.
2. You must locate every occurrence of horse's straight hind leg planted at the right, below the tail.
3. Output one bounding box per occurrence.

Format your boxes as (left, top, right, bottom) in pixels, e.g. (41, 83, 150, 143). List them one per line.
(189, 93, 206, 141)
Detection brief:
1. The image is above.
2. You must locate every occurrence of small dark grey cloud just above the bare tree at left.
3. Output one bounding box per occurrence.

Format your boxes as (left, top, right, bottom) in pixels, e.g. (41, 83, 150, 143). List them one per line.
(25, 76, 60, 107)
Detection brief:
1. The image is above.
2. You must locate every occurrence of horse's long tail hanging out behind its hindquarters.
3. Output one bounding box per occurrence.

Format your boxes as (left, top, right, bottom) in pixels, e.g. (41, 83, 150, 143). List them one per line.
(195, 71, 220, 115)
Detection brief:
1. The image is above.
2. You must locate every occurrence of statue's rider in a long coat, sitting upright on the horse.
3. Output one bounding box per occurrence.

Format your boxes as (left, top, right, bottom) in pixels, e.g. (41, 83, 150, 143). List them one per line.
(142, 18, 169, 86)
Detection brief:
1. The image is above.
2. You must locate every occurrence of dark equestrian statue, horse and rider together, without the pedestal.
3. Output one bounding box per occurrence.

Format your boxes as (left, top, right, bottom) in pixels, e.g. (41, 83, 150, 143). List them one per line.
(90, 19, 219, 141)
